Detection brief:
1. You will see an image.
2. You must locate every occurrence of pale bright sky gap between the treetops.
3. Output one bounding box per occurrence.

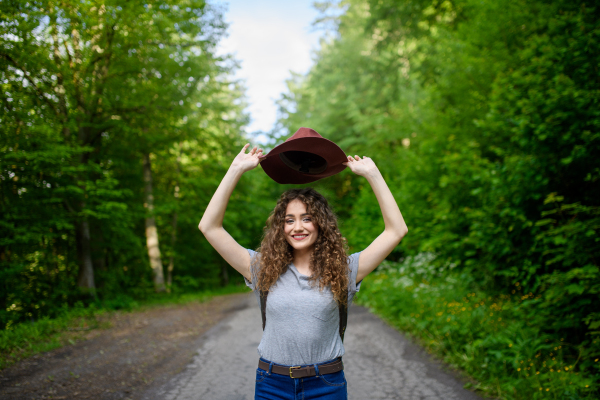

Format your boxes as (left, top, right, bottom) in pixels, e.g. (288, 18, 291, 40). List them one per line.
(217, 0, 321, 144)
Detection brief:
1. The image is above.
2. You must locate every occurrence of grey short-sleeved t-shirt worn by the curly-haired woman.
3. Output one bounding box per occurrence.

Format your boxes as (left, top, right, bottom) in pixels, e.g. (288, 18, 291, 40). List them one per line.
(246, 249, 361, 365)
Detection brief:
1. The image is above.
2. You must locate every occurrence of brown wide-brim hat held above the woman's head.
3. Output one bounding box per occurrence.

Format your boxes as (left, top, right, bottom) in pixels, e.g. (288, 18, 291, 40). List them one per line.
(260, 128, 348, 184)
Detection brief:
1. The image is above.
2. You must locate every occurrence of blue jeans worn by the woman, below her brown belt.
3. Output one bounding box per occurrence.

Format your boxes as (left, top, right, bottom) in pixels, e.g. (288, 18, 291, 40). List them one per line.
(254, 358, 348, 400)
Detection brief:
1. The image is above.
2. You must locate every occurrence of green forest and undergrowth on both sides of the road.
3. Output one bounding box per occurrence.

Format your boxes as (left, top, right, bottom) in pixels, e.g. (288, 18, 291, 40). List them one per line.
(0, 0, 600, 399)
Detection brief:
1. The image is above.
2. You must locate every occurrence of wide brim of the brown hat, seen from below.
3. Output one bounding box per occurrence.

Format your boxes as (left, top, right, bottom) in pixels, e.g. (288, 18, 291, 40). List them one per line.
(260, 137, 348, 184)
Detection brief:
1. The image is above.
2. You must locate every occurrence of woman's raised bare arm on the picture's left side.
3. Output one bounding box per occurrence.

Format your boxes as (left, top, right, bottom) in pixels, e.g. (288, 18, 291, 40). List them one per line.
(198, 144, 264, 280)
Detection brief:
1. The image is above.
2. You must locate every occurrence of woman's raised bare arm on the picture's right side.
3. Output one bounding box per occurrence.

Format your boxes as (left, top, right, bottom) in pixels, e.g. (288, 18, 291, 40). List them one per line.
(345, 156, 408, 282)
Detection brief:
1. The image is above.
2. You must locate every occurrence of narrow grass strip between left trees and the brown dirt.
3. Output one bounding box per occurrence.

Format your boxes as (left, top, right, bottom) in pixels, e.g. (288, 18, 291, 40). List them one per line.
(0, 285, 248, 370)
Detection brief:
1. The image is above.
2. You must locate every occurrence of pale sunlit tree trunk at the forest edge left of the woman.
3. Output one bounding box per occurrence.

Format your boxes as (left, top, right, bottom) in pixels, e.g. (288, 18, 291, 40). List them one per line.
(144, 153, 165, 292)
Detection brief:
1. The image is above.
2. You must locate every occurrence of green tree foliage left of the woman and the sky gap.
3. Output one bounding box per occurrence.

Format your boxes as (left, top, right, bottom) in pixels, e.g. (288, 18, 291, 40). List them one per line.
(0, 0, 261, 328)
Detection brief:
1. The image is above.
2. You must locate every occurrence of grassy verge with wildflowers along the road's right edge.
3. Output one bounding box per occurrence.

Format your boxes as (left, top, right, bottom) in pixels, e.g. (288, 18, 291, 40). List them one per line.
(357, 255, 600, 400)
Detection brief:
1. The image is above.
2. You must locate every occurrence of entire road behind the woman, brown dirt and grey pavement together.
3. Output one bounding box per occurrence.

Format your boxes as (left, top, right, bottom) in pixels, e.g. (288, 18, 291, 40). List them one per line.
(0, 294, 480, 400)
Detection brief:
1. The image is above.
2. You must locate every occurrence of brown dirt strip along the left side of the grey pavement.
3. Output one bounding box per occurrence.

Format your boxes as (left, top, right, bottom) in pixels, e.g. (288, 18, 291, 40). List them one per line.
(0, 294, 248, 400)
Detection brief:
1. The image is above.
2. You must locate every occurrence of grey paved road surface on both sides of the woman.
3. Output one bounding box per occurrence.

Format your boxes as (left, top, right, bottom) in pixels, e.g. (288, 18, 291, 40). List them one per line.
(142, 295, 481, 400)
